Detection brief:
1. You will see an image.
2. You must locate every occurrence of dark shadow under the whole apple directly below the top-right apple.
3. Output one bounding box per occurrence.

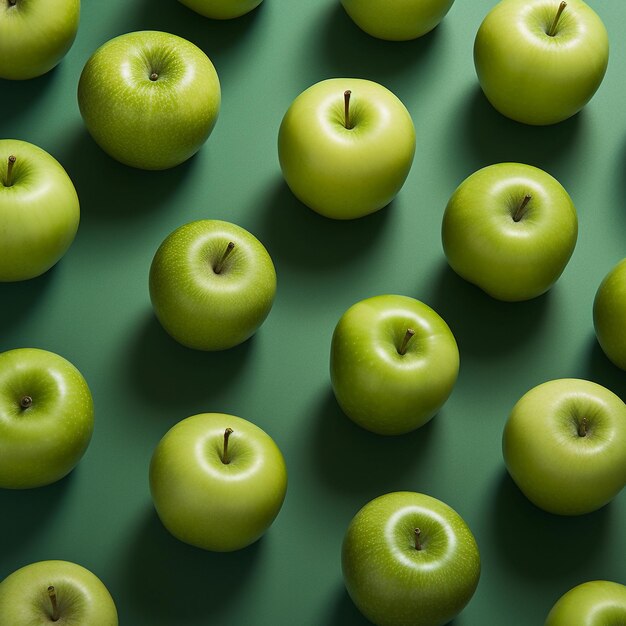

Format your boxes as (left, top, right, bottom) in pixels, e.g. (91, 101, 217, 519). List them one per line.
(427, 263, 558, 359)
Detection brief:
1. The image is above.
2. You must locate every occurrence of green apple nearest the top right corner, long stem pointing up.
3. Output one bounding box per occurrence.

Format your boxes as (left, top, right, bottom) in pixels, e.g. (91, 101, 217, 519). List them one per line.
(474, 0, 609, 125)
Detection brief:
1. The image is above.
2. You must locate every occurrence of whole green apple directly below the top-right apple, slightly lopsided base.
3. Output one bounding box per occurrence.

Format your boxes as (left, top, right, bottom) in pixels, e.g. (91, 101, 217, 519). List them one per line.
(441, 163, 578, 301)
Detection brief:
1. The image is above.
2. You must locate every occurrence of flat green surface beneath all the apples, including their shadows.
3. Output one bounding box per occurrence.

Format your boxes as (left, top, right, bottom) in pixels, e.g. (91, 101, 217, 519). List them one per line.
(0, 0, 626, 626)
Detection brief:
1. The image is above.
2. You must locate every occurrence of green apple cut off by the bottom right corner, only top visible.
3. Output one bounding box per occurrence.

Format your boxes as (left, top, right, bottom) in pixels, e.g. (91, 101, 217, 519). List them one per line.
(544, 580, 626, 626)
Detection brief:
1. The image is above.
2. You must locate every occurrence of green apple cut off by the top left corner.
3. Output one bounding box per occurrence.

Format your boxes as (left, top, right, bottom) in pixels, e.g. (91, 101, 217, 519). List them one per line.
(0, 0, 80, 80)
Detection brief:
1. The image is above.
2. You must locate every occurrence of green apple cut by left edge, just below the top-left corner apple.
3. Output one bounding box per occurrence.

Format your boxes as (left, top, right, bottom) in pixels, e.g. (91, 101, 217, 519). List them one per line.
(0, 139, 80, 282)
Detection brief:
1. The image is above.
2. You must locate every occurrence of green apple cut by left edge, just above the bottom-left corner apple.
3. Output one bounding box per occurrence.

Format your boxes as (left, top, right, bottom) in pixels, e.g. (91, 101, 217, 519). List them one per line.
(0, 348, 93, 489)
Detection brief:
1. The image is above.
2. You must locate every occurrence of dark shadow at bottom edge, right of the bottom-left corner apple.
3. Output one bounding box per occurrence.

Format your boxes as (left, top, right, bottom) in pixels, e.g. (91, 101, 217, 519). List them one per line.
(114, 507, 262, 626)
